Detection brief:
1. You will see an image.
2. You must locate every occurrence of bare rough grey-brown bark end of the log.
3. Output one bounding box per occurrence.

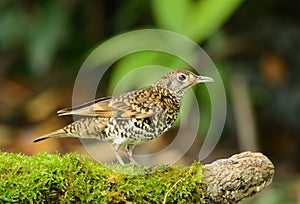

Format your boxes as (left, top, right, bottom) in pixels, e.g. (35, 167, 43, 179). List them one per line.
(203, 152, 274, 203)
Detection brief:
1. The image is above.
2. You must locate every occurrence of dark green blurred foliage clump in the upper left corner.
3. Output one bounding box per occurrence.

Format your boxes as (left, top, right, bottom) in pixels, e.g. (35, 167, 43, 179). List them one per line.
(0, 1, 67, 74)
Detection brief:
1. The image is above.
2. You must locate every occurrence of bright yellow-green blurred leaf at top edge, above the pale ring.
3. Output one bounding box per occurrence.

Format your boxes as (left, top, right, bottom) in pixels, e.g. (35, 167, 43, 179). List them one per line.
(152, 0, 243, 43)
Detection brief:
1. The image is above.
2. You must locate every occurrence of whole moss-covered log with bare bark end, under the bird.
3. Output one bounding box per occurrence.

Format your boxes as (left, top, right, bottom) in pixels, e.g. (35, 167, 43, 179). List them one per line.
(0, 152, 274, 203)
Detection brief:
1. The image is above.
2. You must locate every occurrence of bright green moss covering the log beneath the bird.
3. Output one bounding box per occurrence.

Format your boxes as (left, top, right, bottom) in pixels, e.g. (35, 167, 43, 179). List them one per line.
(0, 152, 204, 203)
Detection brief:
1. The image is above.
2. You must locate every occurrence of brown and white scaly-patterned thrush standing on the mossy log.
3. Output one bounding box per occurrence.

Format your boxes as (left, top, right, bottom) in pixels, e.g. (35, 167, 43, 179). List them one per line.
(33, 70, 214, 165)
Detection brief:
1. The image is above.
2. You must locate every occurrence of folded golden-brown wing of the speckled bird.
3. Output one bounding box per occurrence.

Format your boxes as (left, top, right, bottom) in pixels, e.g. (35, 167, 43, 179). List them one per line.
(57, 93, 161, 118)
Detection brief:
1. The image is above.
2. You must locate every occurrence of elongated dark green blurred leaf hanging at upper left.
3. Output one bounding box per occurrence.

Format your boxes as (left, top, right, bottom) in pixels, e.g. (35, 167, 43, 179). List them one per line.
(27, 1, 66, 75)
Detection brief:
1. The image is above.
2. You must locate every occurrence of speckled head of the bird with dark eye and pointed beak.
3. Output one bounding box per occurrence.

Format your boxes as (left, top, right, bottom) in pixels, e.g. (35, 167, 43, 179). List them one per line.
(153, 70, 214, 99)
